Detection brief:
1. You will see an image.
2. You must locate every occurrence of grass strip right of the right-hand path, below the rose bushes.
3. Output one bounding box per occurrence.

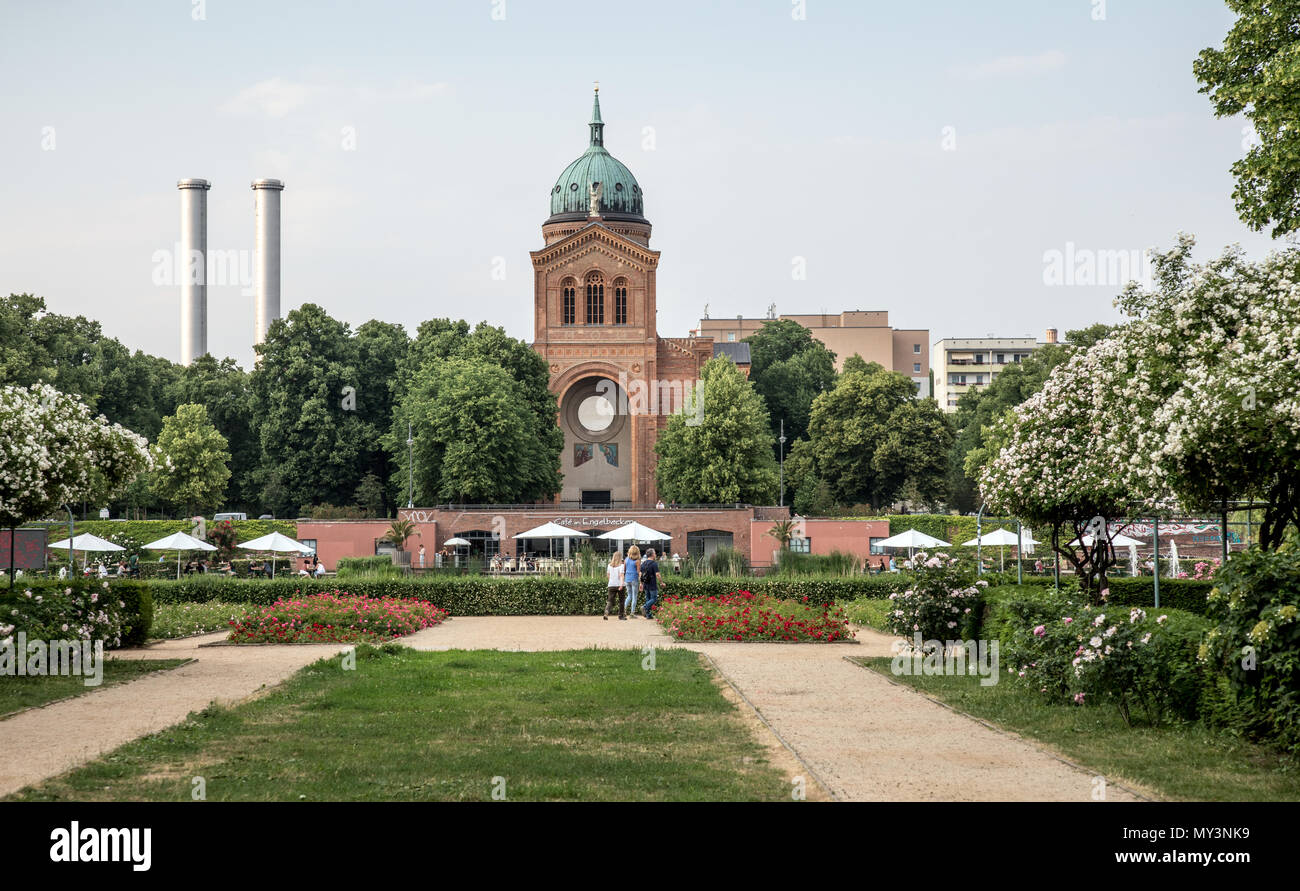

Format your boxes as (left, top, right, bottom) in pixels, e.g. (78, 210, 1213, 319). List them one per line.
(854, 658, 1300, 801)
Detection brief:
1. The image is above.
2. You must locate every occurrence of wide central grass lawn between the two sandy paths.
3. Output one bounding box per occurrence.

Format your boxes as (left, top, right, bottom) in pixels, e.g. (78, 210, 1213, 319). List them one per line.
(10, 644, 790, 801)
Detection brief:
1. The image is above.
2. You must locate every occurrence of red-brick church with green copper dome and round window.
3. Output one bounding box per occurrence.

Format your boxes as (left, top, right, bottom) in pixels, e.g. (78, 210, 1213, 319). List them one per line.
(530, 87, 733, 507)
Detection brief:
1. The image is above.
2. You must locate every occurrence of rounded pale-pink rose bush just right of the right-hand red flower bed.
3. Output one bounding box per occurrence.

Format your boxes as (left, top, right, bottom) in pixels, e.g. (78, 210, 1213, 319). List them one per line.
(888, 552, 988, 640)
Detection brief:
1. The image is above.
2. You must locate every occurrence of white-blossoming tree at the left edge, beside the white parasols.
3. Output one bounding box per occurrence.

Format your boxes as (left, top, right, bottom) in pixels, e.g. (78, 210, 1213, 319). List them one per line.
(0, 384, 150, 585)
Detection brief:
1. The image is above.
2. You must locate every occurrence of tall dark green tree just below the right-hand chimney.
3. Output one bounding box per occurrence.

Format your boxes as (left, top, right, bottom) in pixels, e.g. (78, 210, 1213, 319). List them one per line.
(250, 303, 378, 515)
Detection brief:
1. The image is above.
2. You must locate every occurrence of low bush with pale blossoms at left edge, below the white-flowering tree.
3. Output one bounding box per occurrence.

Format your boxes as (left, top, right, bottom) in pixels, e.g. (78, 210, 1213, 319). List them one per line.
(0, 581, 131, 649)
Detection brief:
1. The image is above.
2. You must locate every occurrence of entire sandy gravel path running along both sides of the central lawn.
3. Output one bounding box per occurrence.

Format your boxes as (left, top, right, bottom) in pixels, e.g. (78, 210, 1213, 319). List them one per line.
(0, 617, 1136, 801)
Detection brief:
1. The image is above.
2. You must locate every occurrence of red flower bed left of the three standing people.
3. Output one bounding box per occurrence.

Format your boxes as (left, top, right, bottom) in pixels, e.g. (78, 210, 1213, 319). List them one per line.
(230, 591, 447, 644)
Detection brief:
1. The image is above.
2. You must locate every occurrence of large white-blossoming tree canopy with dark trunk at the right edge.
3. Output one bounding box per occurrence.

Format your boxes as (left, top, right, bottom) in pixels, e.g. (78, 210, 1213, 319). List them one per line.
(980, 235, 1300, 590)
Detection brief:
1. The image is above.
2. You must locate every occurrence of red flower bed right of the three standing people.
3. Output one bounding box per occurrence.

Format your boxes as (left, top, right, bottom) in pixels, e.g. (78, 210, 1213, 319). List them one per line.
(655, 591, 853, 644)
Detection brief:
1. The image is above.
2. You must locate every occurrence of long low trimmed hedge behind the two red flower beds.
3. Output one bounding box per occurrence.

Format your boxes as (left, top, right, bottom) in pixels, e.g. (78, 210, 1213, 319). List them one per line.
(137, 574, 910, 617)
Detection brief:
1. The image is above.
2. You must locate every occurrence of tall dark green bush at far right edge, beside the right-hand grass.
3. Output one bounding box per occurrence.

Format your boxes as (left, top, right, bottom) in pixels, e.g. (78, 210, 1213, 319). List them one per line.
(1200, 533, 1300, 753)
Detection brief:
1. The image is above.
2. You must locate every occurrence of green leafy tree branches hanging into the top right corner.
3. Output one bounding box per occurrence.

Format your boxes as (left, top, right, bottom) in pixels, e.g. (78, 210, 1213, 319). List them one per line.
(1192, 0, 1300, 238)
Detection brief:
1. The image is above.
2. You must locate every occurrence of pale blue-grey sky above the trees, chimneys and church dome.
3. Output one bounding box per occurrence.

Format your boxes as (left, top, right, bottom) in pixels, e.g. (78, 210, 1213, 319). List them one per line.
(0, 0, 1271, 367)
